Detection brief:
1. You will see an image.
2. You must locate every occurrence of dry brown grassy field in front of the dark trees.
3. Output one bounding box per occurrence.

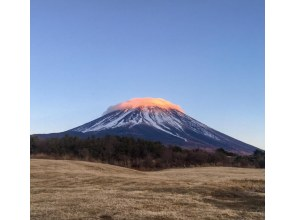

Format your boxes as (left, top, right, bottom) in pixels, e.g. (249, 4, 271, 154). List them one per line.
(31, 159, 265, 220)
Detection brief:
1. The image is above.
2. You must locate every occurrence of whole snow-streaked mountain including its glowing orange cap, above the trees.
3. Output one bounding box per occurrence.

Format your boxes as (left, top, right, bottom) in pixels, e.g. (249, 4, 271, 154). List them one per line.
(37, 98, 257, 154)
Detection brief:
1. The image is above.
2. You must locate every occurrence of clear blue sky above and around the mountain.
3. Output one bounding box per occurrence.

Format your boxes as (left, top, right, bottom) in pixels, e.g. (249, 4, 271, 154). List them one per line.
(30, 0, 265, 149)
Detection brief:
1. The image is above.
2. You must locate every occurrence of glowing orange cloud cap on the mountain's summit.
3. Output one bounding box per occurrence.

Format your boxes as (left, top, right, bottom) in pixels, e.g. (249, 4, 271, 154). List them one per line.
(104, 97, 184, 114)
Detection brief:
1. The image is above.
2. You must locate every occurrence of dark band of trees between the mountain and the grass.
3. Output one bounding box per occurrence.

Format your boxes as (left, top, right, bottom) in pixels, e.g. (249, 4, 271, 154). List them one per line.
(30, 135, 265, 170)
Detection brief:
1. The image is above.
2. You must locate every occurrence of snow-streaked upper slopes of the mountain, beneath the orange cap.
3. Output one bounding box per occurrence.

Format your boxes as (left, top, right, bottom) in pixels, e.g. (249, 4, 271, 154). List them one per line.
(71, 105, 223, 147)
